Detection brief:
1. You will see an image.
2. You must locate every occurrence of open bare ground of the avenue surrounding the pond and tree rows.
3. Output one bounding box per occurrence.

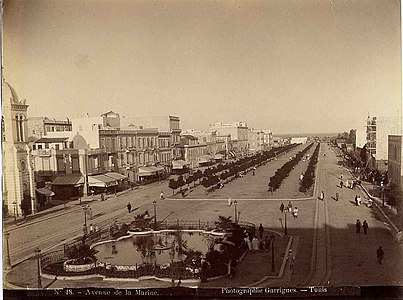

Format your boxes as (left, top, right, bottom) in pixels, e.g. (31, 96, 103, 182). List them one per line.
(6, 144, 402, 288)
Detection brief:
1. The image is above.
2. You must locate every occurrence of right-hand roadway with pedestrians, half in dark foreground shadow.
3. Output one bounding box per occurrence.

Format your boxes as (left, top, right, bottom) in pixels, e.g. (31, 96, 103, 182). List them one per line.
(306, 144, 403, 285)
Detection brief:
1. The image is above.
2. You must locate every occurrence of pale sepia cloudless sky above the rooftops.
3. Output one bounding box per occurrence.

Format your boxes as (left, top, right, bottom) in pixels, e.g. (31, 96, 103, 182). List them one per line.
(3, 0, 402, 133)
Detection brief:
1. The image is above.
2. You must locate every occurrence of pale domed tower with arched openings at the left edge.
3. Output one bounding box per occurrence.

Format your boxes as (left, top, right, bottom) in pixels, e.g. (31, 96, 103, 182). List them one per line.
(1, 78, 37, 216)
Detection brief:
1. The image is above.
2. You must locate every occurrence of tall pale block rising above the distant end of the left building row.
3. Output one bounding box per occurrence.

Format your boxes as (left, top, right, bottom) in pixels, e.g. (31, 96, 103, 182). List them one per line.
(210, 122, 248, 156)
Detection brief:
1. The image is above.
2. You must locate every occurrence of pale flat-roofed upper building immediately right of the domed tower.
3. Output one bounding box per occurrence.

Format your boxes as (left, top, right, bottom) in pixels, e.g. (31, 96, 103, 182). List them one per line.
(28, 117, 72, 140)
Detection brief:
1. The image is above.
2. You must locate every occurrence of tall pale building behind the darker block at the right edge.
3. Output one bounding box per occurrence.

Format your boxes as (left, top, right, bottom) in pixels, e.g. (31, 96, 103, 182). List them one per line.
(366, 116, 402, 171)
